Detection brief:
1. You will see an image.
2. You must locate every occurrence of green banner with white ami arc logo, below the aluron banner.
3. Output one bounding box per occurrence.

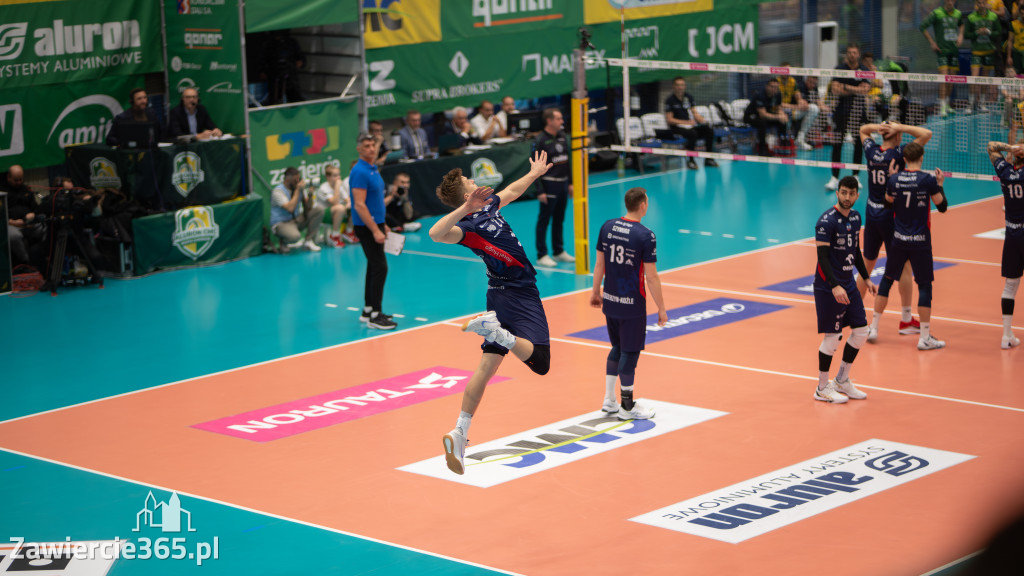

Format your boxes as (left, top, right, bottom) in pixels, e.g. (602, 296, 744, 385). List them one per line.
(0, 76, 145, 171)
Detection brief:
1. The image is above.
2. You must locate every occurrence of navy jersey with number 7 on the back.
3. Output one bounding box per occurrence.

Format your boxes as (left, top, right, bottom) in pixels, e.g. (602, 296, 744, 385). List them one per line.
(887, 170, 939, 247)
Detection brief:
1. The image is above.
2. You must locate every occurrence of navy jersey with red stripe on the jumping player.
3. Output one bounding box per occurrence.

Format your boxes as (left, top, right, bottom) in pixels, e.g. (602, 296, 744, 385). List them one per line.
(456, 194, 537, 287)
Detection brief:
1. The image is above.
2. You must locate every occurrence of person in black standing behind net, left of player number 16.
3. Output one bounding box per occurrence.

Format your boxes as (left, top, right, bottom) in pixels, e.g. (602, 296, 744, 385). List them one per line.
(825, 44, 871, 190)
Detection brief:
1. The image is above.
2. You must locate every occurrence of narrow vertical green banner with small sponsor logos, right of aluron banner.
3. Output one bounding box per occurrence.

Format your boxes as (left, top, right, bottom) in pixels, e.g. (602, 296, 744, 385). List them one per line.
(164, 0, 246, 134)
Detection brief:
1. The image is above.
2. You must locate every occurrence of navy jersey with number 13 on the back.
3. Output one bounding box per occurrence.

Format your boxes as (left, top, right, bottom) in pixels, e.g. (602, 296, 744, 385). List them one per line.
(597, 218, 657, 318)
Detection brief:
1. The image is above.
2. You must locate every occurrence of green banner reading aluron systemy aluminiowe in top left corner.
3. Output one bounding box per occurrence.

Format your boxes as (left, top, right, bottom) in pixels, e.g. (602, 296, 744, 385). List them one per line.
(0, 0, 164, 89)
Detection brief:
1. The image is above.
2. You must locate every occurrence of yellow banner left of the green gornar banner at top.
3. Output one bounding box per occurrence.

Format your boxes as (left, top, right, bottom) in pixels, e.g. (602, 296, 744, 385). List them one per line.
(362, 0, 441, 49)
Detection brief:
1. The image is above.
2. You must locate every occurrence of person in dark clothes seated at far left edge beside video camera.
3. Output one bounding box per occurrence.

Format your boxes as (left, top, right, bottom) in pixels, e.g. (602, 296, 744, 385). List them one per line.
(0, 164, 46, 270)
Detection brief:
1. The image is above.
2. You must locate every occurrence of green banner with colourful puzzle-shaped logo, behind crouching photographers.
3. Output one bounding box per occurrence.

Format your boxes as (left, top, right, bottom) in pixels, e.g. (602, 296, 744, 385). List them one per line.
(249, 99, 359, 220)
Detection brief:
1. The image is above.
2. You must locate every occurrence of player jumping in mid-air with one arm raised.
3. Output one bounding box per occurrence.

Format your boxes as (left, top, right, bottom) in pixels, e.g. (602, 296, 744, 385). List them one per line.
(430, 152, 552, 475)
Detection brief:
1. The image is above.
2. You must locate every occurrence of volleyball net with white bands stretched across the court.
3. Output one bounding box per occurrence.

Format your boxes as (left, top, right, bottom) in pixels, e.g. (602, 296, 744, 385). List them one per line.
(594, 58, 1024, 180)
